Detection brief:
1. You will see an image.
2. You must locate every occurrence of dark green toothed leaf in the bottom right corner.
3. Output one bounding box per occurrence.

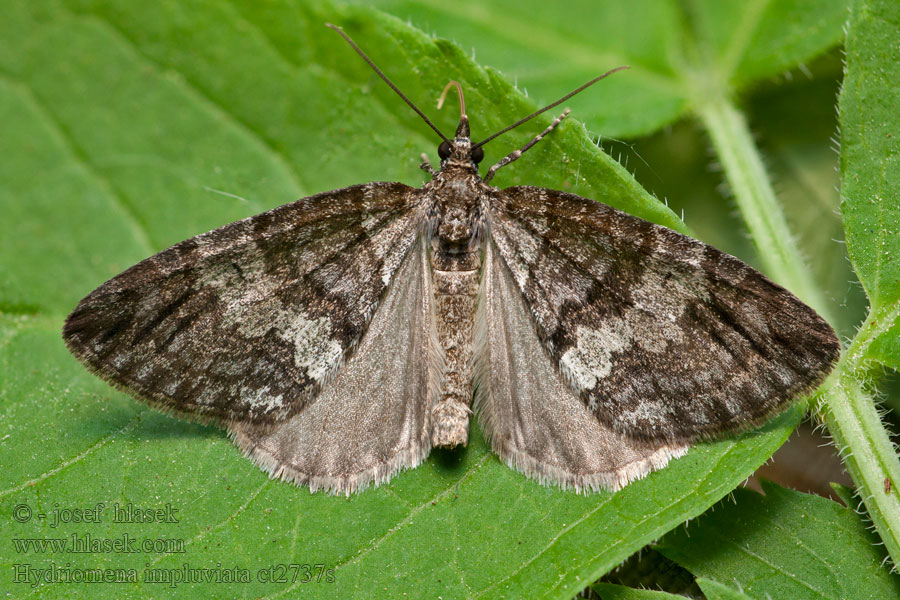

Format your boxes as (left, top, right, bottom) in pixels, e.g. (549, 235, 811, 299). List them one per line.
(658, 483, 900, 600)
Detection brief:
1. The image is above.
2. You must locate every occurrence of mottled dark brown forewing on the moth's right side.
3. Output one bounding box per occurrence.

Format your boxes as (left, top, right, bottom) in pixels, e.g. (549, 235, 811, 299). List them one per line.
(486, 186, 839, 442)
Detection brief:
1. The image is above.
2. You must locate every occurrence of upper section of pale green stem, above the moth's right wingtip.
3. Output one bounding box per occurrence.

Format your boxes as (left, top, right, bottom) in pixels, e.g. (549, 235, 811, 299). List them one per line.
(696, 95, 834, 323)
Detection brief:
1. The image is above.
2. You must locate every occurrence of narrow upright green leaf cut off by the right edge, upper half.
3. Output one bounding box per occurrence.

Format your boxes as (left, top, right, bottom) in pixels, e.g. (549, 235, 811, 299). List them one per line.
(839, 1, 900, 369)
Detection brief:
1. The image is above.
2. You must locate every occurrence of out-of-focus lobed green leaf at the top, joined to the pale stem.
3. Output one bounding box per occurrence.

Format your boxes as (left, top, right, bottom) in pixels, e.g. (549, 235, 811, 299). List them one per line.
(356, 0, 846, 137)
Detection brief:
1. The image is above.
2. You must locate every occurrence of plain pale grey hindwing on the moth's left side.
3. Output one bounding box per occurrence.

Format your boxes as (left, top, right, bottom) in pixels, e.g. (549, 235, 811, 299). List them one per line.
(229, 238, 441, 495)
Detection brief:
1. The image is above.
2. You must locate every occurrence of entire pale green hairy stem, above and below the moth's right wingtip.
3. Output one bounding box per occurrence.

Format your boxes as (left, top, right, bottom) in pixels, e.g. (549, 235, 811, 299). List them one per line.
(697, 95, 900, 565)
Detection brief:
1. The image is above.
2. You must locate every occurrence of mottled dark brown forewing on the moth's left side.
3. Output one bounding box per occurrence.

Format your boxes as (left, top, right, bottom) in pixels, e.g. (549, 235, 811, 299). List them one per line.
(63, 183, 423, 424)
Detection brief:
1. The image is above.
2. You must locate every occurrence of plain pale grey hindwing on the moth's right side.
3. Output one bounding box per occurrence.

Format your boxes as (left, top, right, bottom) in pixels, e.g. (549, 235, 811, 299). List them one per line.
(475, 242, 687, 490)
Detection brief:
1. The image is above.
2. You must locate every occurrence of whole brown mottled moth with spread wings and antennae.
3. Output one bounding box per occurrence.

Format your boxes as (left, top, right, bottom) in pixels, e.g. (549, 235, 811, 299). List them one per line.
(63, 25, 840, 495)
